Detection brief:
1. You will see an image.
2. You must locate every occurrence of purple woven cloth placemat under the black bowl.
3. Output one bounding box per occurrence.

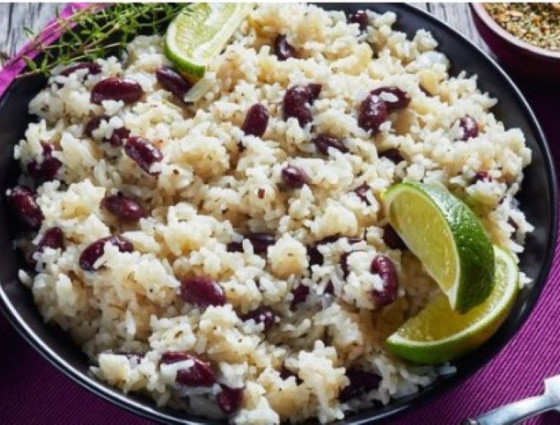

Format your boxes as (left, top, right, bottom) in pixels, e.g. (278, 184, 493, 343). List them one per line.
(0, 3, 560, 425)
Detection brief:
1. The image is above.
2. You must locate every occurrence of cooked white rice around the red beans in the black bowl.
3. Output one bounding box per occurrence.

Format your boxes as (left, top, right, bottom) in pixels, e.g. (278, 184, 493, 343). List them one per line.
(15, 4, 532, 425)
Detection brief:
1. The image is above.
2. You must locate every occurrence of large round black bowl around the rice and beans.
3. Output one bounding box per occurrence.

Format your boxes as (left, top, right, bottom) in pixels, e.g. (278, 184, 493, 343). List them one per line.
(0, 4, 558, 425)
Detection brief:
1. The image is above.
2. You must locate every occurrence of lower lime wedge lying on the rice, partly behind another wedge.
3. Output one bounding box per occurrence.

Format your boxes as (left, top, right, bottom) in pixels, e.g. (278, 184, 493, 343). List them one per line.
(386, 247, 519, 364)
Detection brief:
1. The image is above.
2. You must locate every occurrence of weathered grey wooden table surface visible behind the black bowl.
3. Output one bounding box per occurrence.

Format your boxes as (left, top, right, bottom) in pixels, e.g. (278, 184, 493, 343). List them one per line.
(0, 3, 483, 64)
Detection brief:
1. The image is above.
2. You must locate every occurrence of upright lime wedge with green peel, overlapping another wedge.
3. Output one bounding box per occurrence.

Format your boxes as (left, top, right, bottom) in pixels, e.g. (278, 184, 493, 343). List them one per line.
(383, 183, 494, 313)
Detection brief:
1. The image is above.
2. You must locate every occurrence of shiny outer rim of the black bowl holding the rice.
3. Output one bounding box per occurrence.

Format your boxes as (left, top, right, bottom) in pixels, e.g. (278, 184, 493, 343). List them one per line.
(0, 3, 559, 425)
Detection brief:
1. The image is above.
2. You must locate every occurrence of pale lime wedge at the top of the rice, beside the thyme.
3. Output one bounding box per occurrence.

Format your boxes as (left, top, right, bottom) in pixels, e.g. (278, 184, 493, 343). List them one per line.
(165, 3, 254, 78)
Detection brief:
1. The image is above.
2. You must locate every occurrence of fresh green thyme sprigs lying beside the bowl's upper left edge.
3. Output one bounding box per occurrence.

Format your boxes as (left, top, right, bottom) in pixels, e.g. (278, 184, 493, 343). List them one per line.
(16, 3, 184, 78)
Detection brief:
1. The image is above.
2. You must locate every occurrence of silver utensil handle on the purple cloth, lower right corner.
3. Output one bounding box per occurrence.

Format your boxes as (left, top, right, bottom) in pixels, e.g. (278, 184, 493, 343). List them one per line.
(461, 375, 560, 425)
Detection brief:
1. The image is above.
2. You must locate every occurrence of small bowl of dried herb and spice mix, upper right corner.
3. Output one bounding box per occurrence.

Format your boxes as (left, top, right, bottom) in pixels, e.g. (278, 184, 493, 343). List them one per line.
(471, 3, 560, 81)
